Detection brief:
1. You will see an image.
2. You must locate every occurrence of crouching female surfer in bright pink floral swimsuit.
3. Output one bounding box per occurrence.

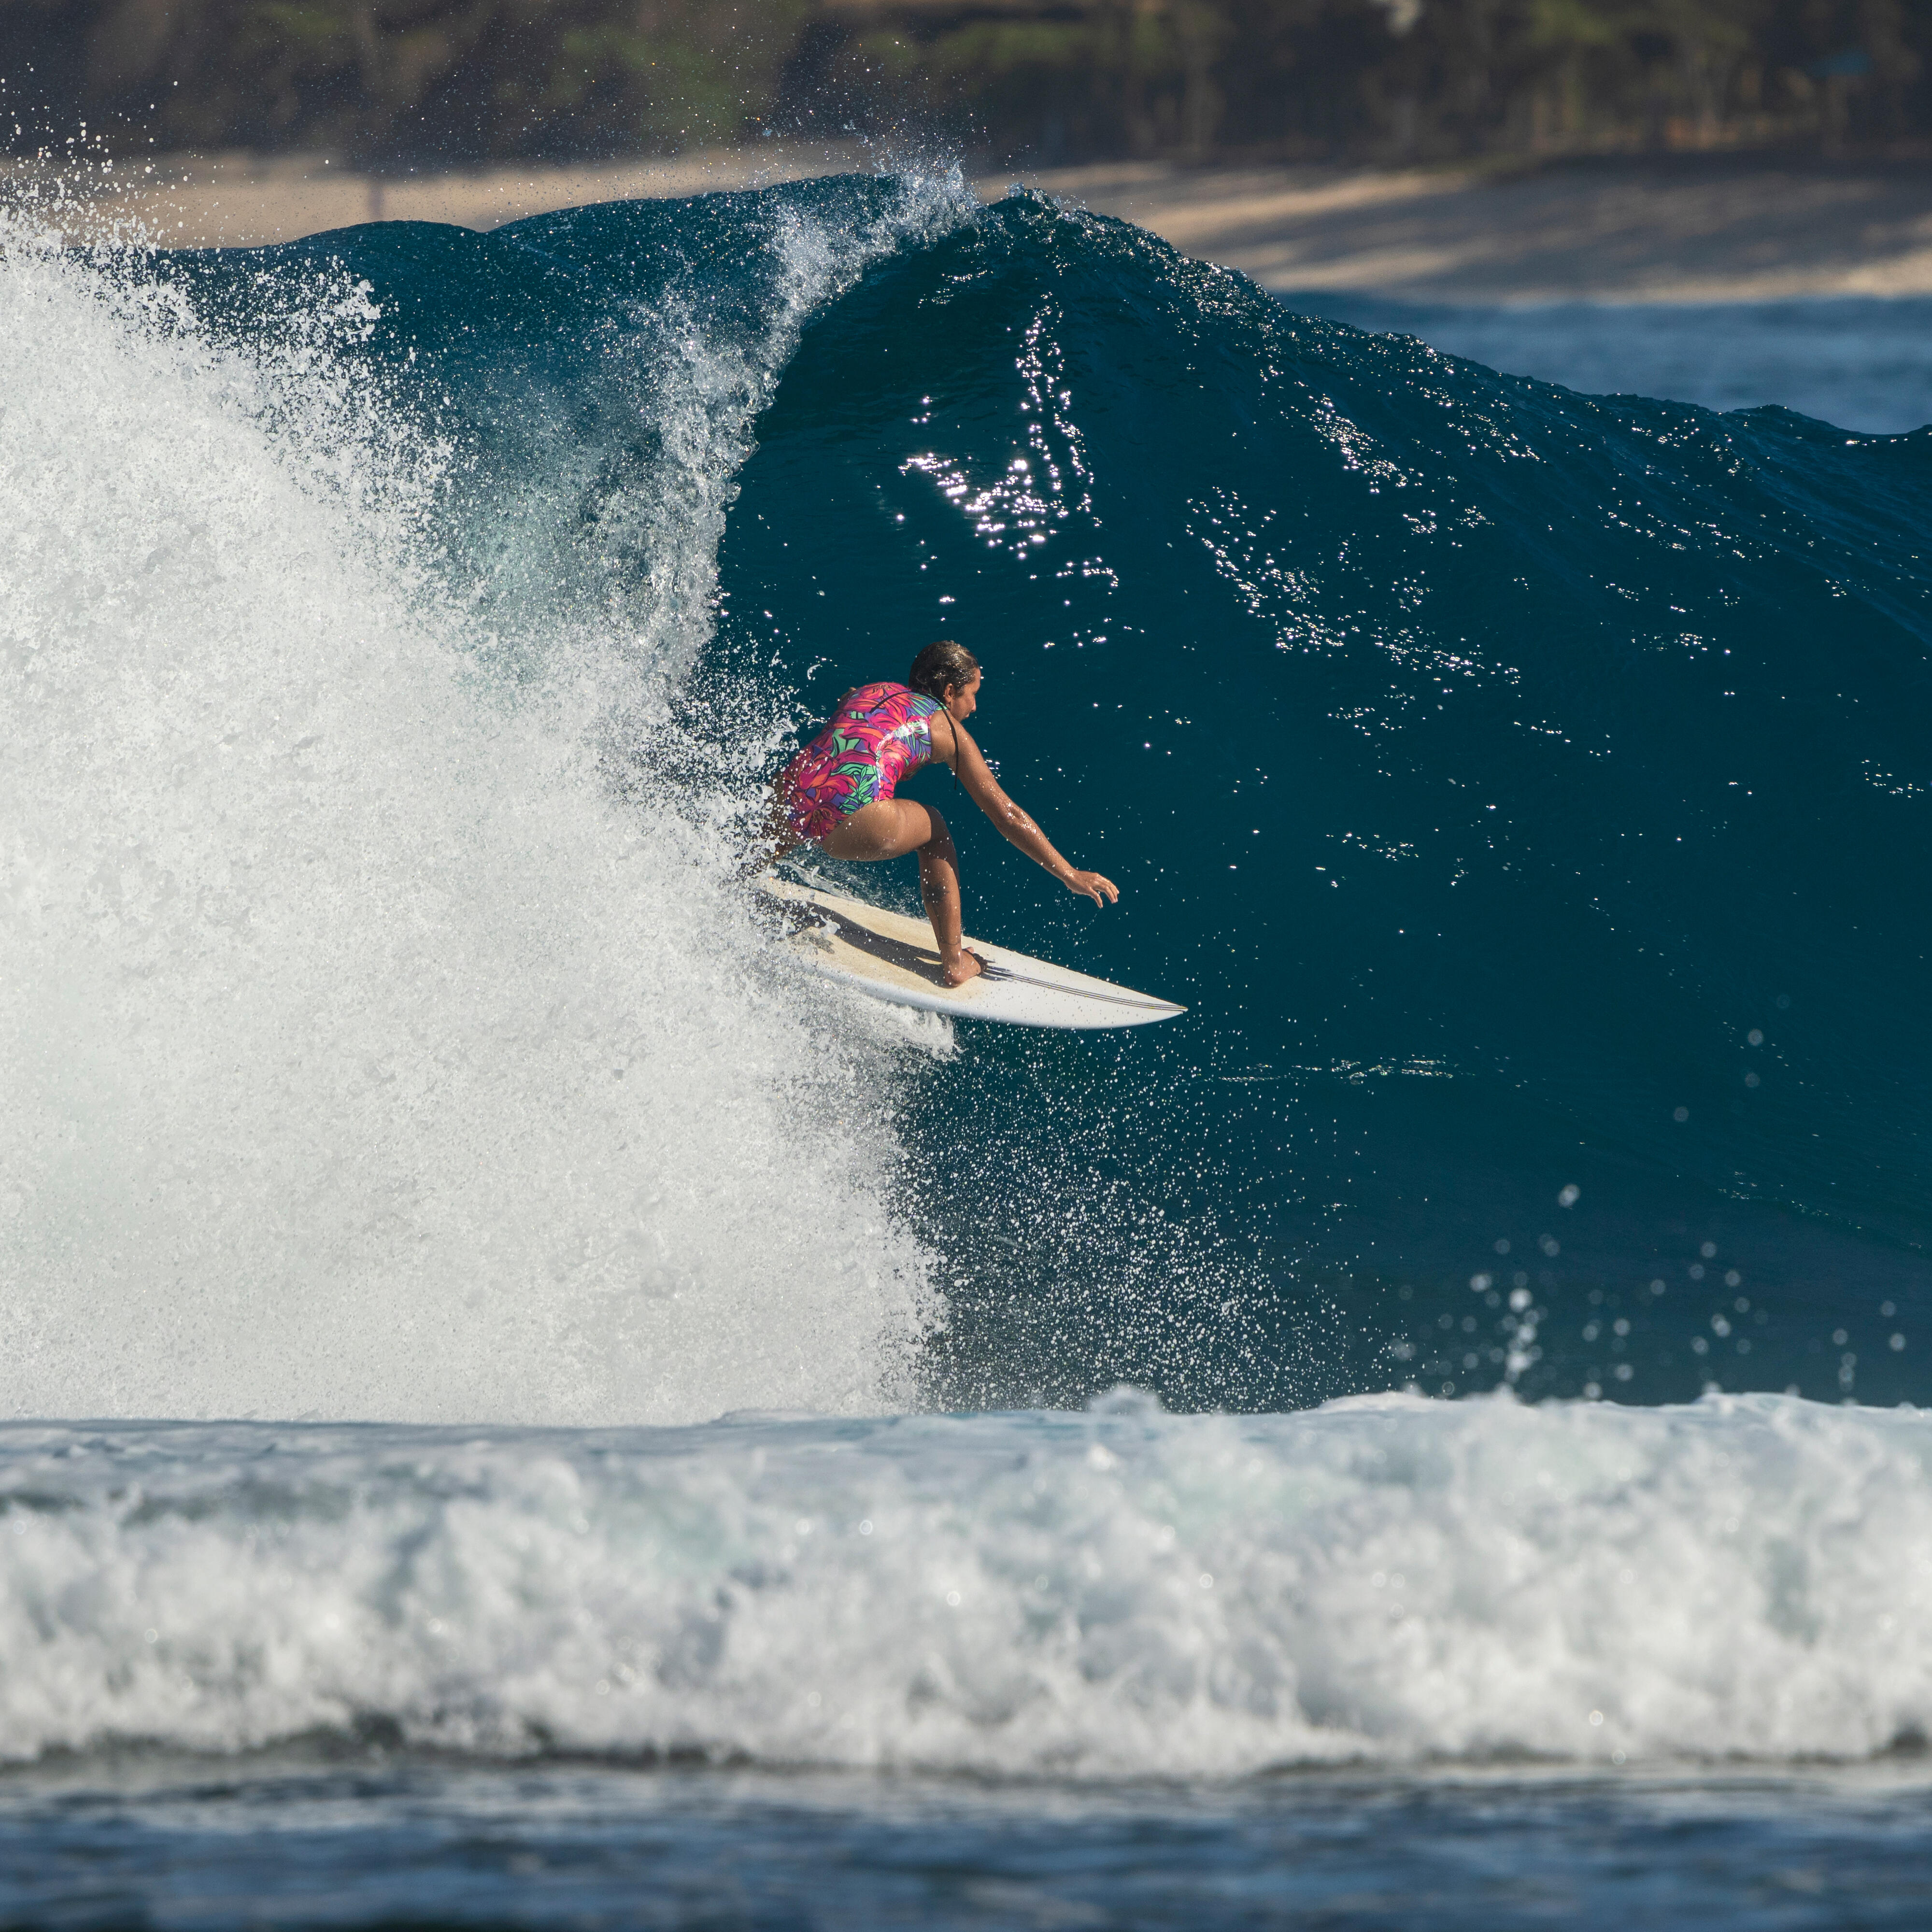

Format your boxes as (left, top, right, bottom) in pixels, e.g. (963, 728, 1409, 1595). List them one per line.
(773, 643, 1121, 985)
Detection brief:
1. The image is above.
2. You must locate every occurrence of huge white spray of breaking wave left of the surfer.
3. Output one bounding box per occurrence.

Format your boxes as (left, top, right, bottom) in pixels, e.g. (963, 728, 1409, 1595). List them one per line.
(0, 178, 966, 1422)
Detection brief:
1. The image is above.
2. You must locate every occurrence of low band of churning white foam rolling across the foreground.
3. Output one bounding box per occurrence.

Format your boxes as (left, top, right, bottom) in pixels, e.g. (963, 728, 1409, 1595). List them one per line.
(0, 1397, 1932, 1777)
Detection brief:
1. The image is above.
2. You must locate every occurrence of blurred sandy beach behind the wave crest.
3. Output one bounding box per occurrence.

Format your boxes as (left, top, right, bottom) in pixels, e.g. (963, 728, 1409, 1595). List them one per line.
(26, 143, 1932, 307)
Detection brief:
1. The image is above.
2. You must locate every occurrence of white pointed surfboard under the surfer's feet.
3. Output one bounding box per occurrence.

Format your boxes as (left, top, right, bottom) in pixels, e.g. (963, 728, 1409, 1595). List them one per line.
(759, 877, 1188, 1028)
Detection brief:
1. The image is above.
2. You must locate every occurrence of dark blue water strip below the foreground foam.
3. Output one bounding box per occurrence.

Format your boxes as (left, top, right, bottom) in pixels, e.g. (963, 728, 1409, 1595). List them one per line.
(11, 1750, 1932, 1932)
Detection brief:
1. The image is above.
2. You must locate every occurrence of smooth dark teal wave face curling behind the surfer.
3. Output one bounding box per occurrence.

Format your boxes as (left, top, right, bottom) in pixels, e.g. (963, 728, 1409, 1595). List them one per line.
(147, 180, 1932, 1403)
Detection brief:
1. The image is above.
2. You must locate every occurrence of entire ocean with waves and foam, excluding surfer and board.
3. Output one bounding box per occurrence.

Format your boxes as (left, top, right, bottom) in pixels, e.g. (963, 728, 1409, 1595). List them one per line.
(0, 176, 1932, 1928)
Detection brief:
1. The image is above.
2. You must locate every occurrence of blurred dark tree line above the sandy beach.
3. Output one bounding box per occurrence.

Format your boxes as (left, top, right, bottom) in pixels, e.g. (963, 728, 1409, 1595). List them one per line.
(11, 0, 1932, 164)
